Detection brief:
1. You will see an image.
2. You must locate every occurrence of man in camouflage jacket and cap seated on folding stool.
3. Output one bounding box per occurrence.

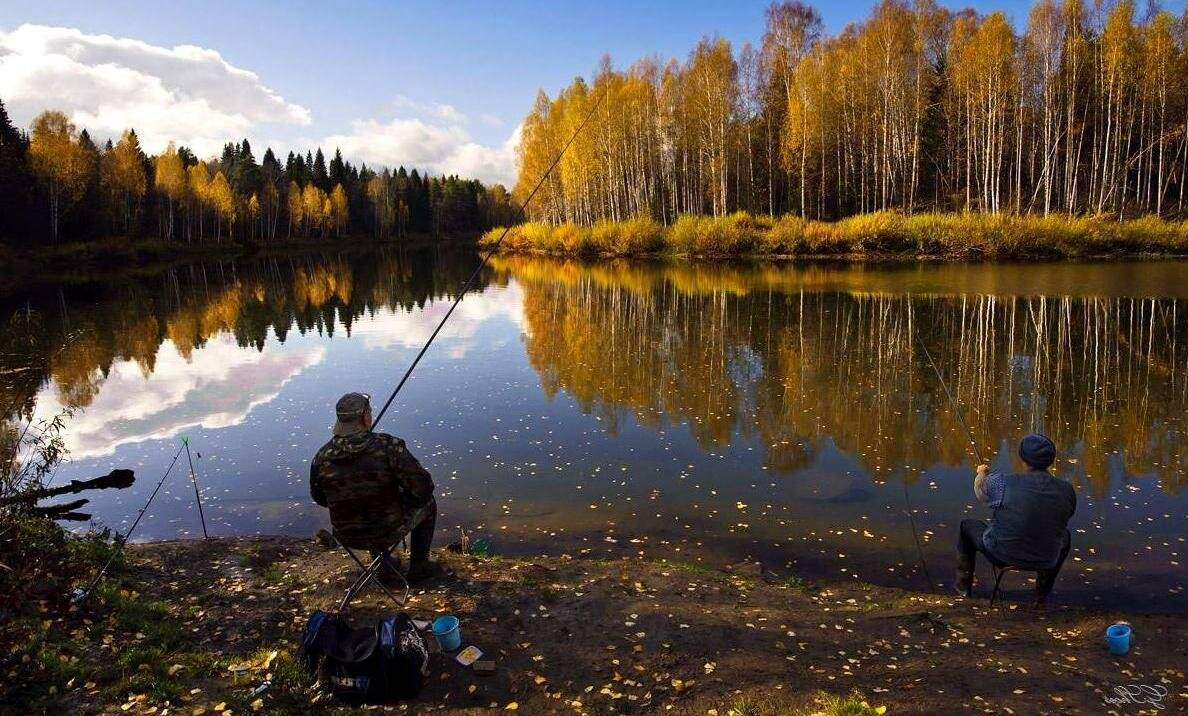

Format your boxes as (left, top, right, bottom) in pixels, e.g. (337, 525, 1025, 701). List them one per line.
(309, 393, 437, 582)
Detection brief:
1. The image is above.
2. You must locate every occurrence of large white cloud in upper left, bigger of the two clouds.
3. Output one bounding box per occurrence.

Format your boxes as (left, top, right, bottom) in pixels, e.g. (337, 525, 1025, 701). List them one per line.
(0, 25, 311, 154)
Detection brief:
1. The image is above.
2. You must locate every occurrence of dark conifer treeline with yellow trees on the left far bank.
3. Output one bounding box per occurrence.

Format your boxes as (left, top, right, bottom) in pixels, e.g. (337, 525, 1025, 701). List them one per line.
(0, 101, 517, 246)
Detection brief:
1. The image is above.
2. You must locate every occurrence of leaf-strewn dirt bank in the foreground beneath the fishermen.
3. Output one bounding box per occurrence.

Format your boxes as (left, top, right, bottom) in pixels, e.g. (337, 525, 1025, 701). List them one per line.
(0, 522, 1184, 716)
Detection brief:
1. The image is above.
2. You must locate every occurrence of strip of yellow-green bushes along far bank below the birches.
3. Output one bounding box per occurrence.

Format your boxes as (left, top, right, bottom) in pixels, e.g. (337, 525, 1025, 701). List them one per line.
(479, 211, 1188, 260)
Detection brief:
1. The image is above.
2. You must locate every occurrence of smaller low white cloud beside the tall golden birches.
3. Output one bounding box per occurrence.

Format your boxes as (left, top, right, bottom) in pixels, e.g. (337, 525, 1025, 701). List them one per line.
(322, 116, 519, 188)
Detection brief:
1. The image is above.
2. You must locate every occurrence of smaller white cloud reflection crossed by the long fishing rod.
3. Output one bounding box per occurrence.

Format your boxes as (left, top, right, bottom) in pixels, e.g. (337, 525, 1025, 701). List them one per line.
(350, 283, 524, 360)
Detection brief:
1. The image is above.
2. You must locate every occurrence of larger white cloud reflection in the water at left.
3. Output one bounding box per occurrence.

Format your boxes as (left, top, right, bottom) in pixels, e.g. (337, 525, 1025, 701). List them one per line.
(37, 335, 326, 458)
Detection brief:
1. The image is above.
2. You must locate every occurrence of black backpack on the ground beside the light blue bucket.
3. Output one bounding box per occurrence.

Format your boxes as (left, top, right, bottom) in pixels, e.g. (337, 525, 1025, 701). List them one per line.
(299, 609, 429, 704)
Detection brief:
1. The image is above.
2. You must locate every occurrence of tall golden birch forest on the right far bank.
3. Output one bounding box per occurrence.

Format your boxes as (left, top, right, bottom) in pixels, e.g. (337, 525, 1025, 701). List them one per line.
(514, 0, 1188, 226)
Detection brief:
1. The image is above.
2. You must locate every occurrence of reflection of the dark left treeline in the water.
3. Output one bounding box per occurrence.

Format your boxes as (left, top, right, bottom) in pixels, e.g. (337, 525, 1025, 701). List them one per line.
(0, 252, 487, 417)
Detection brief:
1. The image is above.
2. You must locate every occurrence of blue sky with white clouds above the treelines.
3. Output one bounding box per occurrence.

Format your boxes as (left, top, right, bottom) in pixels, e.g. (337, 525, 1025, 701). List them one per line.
(0, 0, 1154, 185)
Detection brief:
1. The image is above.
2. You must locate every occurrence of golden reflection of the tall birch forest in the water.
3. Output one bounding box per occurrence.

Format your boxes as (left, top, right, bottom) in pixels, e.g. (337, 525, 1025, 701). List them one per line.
(497, 259, 1188, 493)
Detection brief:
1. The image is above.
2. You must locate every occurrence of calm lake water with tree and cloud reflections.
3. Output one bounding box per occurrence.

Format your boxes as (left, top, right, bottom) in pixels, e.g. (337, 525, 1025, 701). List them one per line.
(0, 253, 1188, 612)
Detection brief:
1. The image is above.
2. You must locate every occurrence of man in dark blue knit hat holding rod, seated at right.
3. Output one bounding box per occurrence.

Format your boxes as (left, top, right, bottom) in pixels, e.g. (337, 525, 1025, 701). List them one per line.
(953, 433, 1076, 607)
